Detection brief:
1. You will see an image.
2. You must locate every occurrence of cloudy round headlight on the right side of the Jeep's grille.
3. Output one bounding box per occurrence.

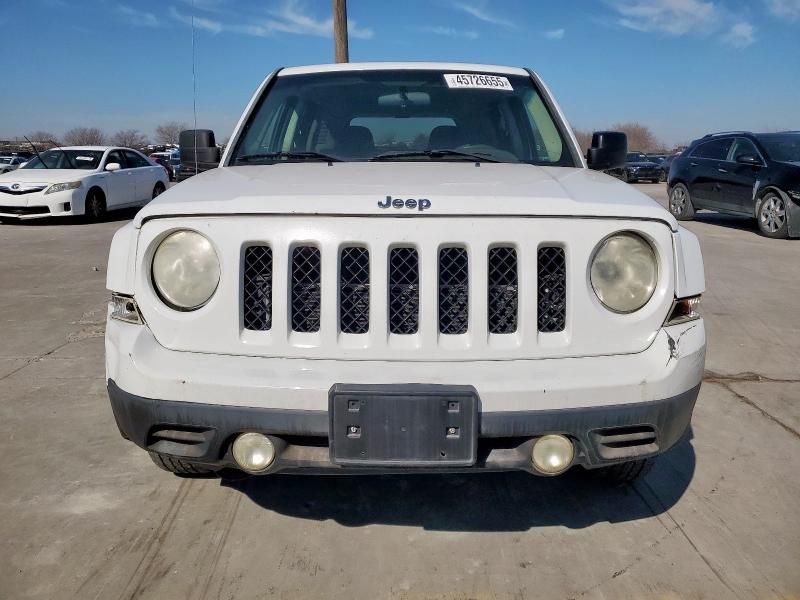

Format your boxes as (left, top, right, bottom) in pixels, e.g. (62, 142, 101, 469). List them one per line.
(591, 232, 658, 313)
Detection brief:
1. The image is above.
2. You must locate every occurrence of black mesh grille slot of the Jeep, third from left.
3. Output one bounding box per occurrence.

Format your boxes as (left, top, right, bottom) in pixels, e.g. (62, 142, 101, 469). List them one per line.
(339, 247, 369, 333)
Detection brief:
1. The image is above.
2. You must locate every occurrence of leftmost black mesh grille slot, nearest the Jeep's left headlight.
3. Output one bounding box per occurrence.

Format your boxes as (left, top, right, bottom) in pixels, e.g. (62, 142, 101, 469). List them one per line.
(242, 246, 272, 331)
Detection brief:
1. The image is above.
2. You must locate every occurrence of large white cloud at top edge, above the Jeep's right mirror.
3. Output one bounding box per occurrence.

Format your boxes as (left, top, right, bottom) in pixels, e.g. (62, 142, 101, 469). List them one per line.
(611, 0, 719, 36)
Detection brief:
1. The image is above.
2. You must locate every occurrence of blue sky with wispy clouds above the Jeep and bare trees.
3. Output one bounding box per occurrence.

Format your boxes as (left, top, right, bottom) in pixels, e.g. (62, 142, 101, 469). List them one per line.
(0, 0, 800, 144)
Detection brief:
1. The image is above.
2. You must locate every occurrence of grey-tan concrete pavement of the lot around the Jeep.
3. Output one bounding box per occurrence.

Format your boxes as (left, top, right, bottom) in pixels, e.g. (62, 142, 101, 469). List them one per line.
(0, 185, 800, 600)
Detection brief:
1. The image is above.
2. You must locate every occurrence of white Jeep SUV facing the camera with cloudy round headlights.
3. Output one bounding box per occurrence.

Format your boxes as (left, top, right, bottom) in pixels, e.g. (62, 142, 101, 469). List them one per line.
(106, 63, 705, 480)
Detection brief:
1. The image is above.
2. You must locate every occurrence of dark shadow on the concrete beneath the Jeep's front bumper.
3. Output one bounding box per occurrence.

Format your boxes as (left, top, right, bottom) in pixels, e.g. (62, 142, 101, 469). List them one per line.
(221, 429, 695, 532)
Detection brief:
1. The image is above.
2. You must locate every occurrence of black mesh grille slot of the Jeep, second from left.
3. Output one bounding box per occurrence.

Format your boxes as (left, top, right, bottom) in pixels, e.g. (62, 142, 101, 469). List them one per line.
(291, 246, 322, 333)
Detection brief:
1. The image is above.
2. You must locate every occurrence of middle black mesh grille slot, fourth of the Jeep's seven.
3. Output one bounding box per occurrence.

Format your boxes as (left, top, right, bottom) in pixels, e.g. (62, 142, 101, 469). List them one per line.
(389, 248, 419, 335)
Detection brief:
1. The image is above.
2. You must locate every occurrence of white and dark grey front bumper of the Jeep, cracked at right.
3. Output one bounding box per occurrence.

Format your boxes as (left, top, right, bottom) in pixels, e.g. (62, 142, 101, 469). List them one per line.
(106, 320, 705, 473)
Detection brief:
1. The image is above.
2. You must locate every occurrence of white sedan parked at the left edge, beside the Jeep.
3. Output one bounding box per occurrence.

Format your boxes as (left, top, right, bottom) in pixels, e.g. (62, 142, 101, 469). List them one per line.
(0, 146, 168, 220)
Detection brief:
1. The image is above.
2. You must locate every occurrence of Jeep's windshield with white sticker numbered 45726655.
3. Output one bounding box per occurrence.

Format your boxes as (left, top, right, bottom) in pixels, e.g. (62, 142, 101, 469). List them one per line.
(230, 70, 575, 166)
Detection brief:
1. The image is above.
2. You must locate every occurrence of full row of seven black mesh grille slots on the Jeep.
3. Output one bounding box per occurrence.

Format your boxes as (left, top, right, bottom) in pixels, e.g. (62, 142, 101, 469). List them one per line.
(242, 245, 567, 335)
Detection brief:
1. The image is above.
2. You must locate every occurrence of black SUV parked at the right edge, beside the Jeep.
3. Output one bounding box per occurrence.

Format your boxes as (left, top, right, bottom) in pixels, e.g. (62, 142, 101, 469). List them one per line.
(668, 131, 800, 238)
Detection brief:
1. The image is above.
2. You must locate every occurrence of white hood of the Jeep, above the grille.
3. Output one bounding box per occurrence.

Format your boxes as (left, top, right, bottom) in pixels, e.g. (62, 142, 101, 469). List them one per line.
(134, 162, 677, 231)
